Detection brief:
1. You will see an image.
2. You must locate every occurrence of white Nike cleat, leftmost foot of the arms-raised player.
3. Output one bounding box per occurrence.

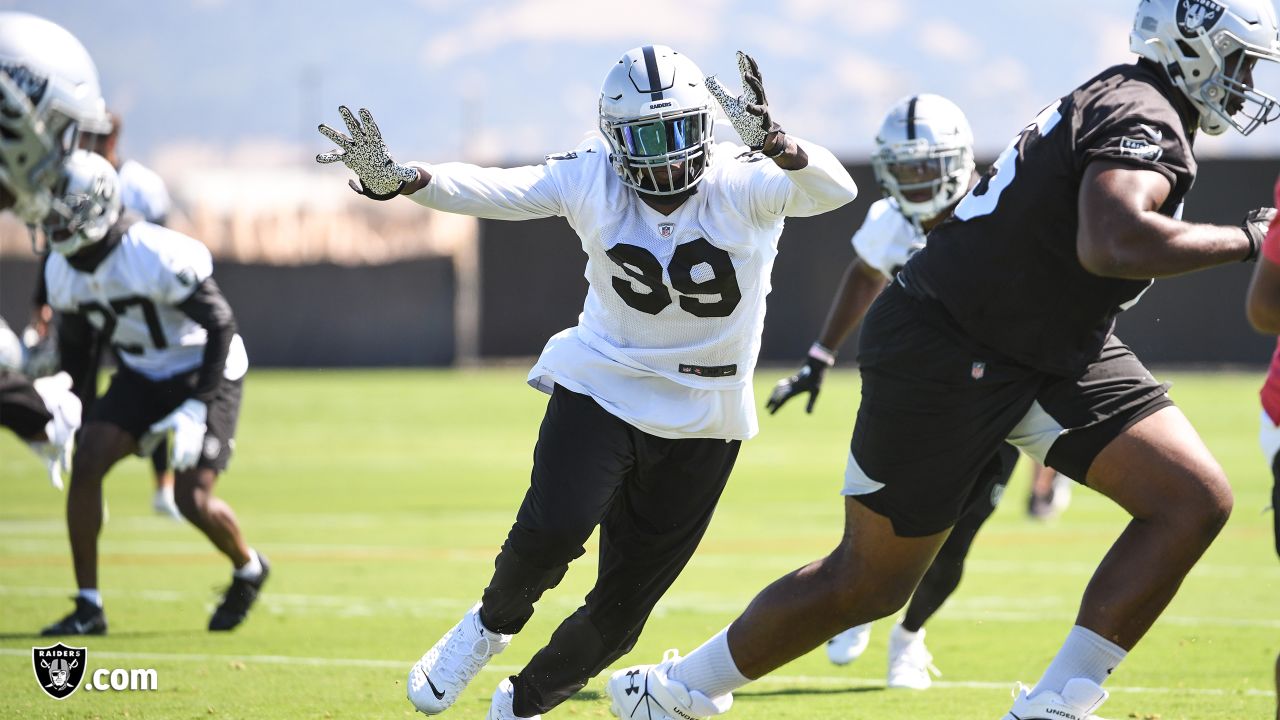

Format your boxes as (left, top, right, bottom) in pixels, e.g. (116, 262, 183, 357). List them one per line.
(407, 602, 511, 715)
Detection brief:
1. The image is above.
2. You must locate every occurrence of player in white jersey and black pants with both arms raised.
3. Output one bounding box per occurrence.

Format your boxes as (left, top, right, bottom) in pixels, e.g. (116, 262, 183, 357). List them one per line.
(316, 45, 856, 720)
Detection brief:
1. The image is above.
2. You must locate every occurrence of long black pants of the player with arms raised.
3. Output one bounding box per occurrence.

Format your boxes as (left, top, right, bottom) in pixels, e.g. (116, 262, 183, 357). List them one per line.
(480, 386, 741, 717)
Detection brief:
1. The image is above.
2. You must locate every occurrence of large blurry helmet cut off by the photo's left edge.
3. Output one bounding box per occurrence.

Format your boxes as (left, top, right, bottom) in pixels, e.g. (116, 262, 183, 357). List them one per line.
(0, 13, 111, 225)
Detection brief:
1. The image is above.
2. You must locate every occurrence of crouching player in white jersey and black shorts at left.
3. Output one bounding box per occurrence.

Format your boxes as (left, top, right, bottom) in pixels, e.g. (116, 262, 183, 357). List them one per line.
(42, 150, 269, 635)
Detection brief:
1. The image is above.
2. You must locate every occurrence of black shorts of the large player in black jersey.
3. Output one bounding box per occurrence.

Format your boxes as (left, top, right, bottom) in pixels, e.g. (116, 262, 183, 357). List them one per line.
(845, 282, 1172, 537)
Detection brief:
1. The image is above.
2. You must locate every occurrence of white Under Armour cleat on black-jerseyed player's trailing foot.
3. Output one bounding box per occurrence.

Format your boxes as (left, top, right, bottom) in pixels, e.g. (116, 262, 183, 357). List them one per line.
(605, 650, 733, 720)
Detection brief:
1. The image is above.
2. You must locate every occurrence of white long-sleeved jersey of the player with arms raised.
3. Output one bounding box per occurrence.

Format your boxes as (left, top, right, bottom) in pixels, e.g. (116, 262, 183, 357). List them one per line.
(412, 136, 856, 439)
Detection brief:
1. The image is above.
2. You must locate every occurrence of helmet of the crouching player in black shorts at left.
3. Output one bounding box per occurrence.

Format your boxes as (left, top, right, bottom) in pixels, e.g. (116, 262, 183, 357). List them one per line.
(44, 150, 122, 255)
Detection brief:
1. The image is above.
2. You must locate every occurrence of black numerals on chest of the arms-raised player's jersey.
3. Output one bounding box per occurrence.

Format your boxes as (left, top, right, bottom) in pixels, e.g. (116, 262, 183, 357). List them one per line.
(605, 238, 742, 318)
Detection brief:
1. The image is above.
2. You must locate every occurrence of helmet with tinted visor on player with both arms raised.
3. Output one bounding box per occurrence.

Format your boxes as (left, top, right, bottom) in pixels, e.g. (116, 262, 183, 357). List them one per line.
(600, 45, 714, 195)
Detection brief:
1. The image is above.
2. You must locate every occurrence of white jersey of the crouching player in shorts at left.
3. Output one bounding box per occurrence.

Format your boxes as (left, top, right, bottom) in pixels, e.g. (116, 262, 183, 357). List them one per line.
(45, 220, 248, 380)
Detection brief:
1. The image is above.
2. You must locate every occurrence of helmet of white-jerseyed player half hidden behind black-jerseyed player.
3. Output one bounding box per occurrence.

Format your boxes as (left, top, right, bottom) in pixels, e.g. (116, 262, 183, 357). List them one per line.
(872, 94, 975, 224)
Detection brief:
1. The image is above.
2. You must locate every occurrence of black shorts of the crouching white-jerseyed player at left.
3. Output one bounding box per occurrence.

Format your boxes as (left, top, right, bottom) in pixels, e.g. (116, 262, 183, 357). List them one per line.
(84, 365, 244, 471)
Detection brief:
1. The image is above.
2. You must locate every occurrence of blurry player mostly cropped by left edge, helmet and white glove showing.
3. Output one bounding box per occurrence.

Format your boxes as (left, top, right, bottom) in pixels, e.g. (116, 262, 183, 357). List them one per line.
(0, 12, 110, 486)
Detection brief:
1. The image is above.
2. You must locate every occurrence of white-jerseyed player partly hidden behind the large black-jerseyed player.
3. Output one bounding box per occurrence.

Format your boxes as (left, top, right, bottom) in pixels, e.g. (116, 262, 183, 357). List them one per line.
(767, 94, 1018, 689)
